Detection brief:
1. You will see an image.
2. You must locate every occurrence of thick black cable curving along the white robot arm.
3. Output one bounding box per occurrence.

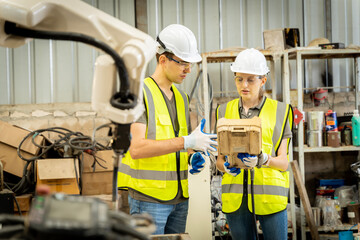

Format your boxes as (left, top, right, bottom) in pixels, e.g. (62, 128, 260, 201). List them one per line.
(4, 21, 137, 109)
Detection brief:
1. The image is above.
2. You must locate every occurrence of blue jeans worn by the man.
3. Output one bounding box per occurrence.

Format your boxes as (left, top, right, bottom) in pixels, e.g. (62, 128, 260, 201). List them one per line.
(129, 195, 189, 235)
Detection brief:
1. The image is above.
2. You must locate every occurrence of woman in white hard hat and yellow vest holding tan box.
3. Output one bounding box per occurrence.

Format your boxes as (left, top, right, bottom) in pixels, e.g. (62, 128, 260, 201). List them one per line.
(216, 49, 293, 240)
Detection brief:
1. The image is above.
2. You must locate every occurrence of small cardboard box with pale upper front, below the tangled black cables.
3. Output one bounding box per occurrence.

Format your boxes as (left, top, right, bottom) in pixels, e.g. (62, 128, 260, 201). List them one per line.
(36, 158, 80, 194)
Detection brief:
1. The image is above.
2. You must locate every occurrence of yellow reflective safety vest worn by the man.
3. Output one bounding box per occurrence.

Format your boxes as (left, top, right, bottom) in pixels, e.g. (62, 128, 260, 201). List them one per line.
(118, 78, 189, 201)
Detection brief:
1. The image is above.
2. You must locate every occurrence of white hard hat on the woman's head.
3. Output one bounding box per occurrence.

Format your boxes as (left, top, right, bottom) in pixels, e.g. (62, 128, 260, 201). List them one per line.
(230, 48, 269, 75)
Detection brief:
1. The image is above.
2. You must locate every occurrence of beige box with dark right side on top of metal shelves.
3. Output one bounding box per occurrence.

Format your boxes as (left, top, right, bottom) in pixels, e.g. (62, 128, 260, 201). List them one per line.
(263, 28, 300, 51)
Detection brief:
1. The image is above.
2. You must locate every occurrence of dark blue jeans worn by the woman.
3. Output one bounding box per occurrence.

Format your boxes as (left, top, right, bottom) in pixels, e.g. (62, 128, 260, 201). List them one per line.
(226, 195, 287, 240)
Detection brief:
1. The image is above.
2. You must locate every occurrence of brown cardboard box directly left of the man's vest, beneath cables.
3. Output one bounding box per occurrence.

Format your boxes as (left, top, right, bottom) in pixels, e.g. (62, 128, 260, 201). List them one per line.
(81, 150, 114, 195)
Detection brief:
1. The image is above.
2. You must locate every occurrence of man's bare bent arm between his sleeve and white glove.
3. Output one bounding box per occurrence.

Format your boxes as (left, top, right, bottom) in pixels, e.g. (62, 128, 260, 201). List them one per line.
(129, 123, 184, 159)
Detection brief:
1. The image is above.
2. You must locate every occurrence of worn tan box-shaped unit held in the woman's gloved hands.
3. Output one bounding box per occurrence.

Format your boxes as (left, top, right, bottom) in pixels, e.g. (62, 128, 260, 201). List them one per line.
(217, 117, 262, 165)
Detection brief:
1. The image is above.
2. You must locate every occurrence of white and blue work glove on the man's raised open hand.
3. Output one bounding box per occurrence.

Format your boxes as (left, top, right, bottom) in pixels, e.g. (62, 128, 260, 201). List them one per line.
(183, 119, 218, 156)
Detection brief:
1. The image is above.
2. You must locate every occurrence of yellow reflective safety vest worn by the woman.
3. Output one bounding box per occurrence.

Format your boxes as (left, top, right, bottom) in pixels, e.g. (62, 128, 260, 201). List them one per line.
(217, 98, 293, 215)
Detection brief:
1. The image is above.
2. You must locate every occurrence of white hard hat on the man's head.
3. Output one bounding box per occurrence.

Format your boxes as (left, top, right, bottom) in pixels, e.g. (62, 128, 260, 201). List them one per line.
(156, 24, 201, 63)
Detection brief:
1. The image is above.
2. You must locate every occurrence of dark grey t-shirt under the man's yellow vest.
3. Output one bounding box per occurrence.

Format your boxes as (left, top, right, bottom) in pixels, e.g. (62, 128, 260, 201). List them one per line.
(129, 85, 191, 204)
